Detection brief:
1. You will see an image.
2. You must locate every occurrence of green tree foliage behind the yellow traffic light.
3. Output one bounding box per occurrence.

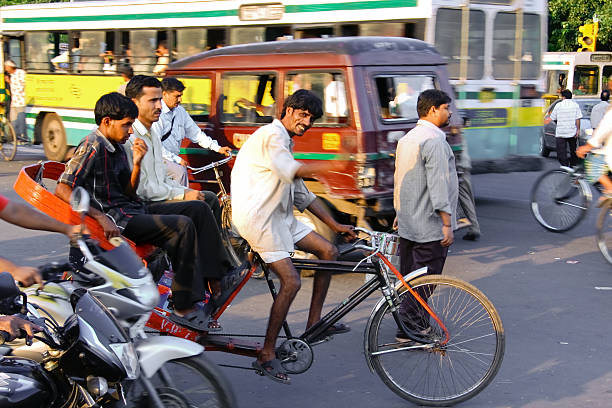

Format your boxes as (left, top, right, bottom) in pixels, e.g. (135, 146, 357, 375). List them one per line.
(548, 0, 612, 52)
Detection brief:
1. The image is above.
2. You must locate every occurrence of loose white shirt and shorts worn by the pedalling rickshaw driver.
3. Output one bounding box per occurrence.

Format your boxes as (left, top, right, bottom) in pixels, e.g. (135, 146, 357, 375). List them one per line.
(232, 119, 316, 263)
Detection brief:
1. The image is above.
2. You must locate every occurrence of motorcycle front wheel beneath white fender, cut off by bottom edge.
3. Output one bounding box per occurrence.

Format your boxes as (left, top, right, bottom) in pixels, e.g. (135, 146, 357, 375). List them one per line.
(128, 354, 237, 408)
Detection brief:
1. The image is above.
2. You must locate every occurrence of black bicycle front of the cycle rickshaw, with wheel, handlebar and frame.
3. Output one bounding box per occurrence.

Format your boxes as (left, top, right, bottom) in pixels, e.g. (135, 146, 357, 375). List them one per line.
(208, 228, 505, 406)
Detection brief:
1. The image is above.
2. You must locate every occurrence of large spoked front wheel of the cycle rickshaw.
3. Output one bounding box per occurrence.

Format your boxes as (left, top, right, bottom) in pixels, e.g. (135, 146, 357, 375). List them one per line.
(366, 275, 505, 406)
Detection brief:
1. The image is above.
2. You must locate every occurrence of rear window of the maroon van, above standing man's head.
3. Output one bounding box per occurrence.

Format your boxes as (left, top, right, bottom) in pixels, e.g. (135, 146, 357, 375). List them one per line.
(375, 75, 435, 121)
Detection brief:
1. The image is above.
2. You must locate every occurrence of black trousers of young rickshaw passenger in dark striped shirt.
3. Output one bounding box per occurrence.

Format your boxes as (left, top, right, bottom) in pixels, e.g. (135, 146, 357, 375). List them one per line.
(123, 201, 230, 309)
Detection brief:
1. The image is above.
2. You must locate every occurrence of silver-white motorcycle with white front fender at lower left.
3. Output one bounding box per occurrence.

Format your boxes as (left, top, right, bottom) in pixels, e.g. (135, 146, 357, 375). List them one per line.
(12, 188, 236, 408)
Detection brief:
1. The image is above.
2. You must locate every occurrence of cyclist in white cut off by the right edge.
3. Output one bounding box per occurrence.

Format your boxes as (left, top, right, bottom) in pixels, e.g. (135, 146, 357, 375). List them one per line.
(576, 93, 612, 198)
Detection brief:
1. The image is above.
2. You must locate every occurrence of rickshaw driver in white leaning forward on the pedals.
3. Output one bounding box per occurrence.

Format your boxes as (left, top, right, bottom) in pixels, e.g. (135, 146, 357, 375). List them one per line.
(231, 90, 356, 384)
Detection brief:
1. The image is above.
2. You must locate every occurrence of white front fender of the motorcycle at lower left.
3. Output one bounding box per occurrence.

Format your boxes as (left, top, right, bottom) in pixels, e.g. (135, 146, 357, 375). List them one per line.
(136, 336, 204, 378)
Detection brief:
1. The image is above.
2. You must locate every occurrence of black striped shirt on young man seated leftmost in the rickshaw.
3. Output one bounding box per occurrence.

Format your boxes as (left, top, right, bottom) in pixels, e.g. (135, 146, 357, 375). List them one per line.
(58, 129, 146, 230)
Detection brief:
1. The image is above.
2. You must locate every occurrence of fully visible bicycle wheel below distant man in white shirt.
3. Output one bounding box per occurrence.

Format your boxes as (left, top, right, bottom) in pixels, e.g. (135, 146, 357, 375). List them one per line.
(530, 169, 591, 232)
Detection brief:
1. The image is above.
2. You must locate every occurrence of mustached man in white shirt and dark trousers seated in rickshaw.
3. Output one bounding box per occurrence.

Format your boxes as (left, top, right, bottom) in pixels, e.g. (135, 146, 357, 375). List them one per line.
(125, 75, 246, 330)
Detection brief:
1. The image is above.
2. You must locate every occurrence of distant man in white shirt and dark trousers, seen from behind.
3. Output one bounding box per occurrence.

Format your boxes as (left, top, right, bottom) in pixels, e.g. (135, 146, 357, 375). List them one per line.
(550, 89, 582, 167)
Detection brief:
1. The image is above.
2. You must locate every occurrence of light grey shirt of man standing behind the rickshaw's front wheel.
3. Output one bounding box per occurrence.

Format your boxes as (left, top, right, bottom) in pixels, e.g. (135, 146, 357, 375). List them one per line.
(393, 120, 458, 242)
